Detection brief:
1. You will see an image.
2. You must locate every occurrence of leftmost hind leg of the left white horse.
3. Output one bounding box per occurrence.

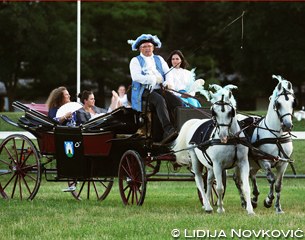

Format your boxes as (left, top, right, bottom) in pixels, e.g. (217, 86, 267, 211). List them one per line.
(189, 150, 213, 213)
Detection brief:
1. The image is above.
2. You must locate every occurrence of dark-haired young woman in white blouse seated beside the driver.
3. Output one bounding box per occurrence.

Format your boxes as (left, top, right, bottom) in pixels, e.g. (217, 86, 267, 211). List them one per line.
(164, 50, 201, 107)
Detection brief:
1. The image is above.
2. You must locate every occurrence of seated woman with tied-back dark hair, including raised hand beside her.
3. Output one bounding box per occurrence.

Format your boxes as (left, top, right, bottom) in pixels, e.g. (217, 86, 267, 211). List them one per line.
(76, 90, 119, 124)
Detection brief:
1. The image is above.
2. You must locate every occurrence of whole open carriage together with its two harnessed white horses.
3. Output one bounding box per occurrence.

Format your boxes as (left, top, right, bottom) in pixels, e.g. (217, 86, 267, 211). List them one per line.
(0, 76, 296, 214)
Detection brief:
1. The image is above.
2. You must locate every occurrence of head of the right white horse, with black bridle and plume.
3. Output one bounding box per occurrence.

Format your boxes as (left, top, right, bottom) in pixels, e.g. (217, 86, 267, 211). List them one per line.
(270, 75, 297, 132)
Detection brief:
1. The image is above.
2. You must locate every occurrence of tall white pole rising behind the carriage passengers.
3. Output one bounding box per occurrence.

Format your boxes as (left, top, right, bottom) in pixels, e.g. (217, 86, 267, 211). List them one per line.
(76, 0, 81, 101)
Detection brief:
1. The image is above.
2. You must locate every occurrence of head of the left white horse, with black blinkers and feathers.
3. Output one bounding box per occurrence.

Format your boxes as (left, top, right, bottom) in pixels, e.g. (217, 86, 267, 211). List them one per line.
(210, 84, 237, 143)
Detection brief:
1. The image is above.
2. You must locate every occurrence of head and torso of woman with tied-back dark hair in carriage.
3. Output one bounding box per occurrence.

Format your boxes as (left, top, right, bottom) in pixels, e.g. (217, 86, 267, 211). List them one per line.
(76, 90, 108, 125)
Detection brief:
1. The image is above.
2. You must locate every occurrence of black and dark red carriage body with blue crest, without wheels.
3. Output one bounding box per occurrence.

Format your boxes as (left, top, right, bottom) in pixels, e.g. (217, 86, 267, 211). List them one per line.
(5, 102, 145, 180)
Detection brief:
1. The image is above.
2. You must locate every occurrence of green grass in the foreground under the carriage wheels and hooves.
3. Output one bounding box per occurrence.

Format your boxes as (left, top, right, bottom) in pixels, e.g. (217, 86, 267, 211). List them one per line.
(0, 179, 305, 239)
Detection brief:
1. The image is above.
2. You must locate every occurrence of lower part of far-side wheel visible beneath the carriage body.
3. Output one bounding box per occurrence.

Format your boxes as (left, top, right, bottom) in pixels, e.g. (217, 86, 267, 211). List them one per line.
(68, 178, 113, 201)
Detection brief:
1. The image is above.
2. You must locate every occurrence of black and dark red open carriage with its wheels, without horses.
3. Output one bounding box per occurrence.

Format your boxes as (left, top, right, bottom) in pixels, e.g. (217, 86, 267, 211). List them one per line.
(0, 102, 213, 205)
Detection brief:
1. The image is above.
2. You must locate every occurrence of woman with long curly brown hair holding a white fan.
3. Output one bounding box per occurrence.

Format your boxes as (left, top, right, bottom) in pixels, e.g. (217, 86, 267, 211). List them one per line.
(46, 86, 76, 126)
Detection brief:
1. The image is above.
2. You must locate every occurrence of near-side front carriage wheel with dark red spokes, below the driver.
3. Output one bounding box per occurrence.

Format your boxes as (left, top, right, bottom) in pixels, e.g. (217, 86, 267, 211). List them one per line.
(118, 150, 146, 206)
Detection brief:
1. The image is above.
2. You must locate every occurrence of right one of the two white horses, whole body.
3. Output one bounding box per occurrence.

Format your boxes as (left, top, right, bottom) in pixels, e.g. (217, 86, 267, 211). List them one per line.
(240, 75, 296, 213)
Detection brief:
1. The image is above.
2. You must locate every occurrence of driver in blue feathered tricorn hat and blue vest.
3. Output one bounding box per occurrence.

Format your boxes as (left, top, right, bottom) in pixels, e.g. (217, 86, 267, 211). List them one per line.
(128, 34, 183, 143)
